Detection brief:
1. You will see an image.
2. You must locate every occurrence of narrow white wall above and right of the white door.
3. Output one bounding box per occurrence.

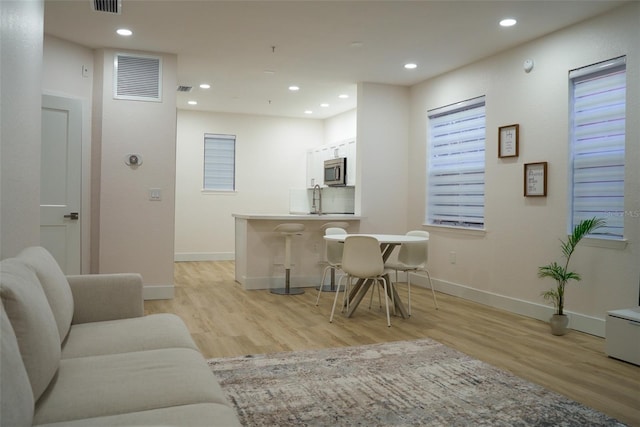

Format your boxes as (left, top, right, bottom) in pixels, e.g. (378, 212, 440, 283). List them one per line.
(42, 35, 94, 273)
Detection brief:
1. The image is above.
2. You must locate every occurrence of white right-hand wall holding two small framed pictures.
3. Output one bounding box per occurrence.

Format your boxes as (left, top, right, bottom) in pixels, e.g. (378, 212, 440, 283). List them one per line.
(406, 3, 640, 335)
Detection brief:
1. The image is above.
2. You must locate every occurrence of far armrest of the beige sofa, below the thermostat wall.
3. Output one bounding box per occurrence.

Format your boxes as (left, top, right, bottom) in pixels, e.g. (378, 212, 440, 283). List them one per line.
(67, 273, 144, 324)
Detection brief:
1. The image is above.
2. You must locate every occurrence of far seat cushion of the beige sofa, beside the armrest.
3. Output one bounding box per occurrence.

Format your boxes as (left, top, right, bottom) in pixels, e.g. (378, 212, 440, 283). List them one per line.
(62, 313, 198, 359)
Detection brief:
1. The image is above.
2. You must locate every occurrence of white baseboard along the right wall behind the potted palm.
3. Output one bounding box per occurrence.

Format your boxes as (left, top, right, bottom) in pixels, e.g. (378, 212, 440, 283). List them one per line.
(411, 275, 605, 338)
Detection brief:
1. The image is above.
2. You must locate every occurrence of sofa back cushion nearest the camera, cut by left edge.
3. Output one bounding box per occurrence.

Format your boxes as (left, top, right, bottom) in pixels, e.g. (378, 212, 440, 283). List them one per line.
(0, 304, 34, 427)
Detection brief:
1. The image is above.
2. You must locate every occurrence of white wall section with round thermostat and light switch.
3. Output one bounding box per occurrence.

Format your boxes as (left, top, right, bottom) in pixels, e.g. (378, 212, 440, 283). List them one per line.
(92, 50, 177, 298)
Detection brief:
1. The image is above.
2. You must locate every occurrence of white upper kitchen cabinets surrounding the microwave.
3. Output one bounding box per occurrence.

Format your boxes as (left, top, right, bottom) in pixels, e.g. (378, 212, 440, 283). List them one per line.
(307, 139, 356, 187)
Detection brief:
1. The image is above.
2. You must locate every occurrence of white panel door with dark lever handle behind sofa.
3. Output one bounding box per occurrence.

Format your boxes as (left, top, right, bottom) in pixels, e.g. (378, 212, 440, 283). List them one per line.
(40, 95, 82, 274)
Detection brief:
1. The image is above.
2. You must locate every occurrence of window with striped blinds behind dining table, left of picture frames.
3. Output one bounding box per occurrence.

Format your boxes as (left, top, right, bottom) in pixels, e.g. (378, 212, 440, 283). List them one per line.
(427, 96, 485, 228)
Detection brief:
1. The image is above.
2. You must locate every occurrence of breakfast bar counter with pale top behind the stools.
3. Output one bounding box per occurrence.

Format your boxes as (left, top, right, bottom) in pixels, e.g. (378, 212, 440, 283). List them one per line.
(233, 214, 362, 290)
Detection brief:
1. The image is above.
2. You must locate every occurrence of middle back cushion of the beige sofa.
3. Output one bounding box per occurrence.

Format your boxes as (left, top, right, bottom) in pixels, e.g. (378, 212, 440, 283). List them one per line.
(0, 258, 60, 400)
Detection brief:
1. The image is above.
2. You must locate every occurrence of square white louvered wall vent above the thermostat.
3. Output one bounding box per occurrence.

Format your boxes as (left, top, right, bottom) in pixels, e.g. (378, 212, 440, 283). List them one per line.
(113, 53, 162, 102)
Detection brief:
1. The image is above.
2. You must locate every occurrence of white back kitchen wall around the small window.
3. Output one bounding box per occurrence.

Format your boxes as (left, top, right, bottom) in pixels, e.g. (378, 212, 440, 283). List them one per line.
(175, 110, 323, 260)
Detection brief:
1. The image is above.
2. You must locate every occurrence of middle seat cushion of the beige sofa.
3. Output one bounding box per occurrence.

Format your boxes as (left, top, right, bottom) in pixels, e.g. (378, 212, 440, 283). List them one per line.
(34, 349, 228, 424)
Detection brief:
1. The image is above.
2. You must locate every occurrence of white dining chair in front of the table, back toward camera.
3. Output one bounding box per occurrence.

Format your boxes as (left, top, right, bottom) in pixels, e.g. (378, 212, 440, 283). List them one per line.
(329, 236, 391, 327)
